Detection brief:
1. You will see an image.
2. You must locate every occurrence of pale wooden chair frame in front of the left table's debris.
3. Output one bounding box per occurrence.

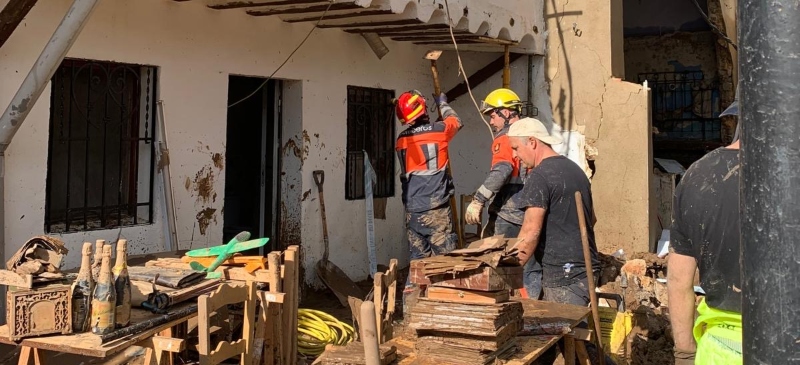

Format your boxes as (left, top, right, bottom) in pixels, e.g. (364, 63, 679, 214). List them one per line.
(197, 281, 257, 365)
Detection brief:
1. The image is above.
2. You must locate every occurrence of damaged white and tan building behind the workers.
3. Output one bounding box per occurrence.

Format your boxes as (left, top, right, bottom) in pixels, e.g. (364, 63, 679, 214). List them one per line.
(0, 0, 735, 318)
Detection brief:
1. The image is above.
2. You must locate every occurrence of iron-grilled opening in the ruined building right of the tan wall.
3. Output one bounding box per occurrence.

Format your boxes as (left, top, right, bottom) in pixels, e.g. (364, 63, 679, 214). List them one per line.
(639, 71, 722, 141)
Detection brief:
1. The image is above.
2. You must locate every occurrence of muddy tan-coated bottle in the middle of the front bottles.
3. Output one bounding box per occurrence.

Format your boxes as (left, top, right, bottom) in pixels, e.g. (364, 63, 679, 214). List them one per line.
(91, 245, 117, 335)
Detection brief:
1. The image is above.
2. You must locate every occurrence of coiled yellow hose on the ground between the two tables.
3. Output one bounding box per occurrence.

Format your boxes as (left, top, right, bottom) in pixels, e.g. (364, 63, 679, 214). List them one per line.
(297, 308, 355, 356)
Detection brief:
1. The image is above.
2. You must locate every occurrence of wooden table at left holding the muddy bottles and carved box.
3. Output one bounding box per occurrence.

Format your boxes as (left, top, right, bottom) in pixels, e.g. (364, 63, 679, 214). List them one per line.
(0, 303, 197, 365)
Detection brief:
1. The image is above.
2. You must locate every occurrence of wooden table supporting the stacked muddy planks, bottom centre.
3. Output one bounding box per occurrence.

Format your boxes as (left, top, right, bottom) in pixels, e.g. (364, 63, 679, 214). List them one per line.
(386, 299, 591, 365)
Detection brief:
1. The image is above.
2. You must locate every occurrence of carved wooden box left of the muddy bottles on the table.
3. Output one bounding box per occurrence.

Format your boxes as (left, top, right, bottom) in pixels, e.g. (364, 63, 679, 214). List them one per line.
(6, 285, 72, 341)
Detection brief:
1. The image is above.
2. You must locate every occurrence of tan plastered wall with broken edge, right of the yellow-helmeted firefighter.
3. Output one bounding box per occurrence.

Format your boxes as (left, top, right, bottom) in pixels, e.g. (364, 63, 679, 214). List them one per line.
(545, 0, 656, 252)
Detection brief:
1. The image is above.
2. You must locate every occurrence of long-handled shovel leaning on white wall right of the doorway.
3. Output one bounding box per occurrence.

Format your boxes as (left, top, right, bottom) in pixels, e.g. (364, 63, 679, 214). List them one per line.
(313, 170, 366, 307)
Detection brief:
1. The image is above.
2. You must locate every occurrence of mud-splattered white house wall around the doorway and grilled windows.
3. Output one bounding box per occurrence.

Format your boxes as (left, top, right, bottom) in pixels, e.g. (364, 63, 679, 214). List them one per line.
(0, 0, 549, 283)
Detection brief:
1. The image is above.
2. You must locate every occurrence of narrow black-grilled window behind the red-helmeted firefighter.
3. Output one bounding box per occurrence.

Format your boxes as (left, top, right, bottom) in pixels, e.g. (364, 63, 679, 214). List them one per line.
(345, 86, 395, 200)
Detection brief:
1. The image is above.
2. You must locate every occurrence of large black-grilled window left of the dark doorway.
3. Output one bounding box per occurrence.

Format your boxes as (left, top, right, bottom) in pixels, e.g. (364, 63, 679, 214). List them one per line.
(45, 59, 157, 233)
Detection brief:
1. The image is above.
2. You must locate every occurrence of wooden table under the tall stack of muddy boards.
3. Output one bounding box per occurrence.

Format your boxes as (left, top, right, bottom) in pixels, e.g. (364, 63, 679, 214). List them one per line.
(385, 298, 591, 365)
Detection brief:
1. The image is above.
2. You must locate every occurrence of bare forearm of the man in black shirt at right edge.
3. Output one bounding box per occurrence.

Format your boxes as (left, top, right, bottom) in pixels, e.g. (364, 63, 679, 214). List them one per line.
(667, 252, 697, 352)
